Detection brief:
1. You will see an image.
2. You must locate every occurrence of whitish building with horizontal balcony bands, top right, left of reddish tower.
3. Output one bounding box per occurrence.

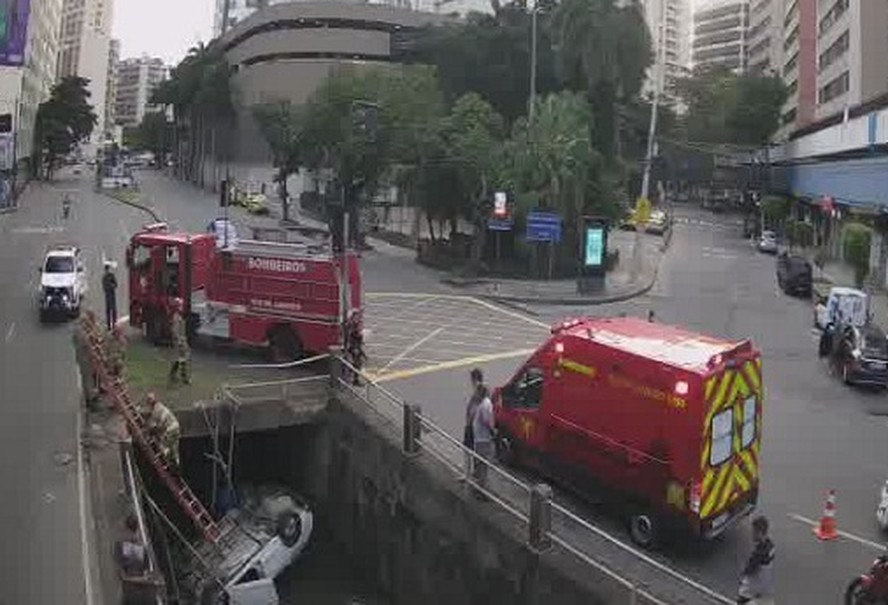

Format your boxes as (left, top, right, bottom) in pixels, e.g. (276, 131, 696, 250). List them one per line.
(692, 0, 749, 72)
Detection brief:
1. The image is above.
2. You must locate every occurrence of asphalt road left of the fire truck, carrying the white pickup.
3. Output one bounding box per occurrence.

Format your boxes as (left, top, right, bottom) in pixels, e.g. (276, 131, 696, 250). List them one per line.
(0, 171, 284, 605)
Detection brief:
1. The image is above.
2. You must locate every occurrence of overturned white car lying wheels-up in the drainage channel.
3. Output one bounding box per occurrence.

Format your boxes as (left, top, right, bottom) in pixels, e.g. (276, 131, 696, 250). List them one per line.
(179, 486, 313, 605)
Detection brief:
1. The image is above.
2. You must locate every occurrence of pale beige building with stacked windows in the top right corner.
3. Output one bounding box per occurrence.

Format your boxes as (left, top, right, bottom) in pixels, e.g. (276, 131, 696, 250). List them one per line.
(816, 0, 888, 119)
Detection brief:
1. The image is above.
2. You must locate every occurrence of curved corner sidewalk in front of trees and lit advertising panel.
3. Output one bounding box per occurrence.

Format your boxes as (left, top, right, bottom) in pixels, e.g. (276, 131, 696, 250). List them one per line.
(442, 231, 671, 305)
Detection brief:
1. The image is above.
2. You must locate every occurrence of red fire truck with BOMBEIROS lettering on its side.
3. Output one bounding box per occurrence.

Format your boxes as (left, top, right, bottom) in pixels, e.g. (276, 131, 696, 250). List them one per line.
(126, 223, 362, 361)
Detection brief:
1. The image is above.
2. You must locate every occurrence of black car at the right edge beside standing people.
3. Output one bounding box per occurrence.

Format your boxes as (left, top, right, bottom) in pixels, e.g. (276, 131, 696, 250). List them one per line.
(833, 324, 888, 389)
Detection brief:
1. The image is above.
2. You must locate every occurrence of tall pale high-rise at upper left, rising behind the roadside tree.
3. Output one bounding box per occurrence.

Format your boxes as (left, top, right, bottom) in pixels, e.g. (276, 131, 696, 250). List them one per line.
(57, 0, 113, 148)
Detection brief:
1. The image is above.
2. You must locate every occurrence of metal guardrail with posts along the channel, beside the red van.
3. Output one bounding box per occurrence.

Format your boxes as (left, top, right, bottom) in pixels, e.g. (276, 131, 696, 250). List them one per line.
(330, 356, 735, 605)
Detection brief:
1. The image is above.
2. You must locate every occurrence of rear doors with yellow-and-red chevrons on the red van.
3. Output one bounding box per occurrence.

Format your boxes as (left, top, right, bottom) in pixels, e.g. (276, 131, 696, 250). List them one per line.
(694, 353, 763, 533)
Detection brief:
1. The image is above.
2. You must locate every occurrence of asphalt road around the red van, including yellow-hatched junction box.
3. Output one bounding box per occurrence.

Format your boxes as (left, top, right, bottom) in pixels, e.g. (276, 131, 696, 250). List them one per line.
(367, 209, 888, 605)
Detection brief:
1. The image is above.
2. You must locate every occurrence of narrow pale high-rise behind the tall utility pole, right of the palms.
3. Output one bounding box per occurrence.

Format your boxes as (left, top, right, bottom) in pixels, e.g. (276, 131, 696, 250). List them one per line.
(641, 0, 691, 105)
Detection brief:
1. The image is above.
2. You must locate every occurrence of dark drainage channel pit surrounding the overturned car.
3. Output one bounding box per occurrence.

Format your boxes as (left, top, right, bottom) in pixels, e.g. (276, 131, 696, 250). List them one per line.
(137, 423, 388, 605)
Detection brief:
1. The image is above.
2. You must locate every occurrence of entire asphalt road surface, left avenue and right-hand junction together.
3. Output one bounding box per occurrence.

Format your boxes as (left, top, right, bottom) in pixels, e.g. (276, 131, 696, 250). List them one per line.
(12, 168, 888, 604)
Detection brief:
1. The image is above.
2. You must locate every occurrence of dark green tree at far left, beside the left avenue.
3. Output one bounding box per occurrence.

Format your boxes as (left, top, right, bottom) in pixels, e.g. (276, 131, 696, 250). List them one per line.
(34, 76, 98, 179)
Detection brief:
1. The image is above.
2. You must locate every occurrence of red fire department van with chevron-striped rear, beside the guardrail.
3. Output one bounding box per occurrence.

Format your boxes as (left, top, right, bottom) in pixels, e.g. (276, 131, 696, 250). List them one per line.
(494, 317, 763, 546)
